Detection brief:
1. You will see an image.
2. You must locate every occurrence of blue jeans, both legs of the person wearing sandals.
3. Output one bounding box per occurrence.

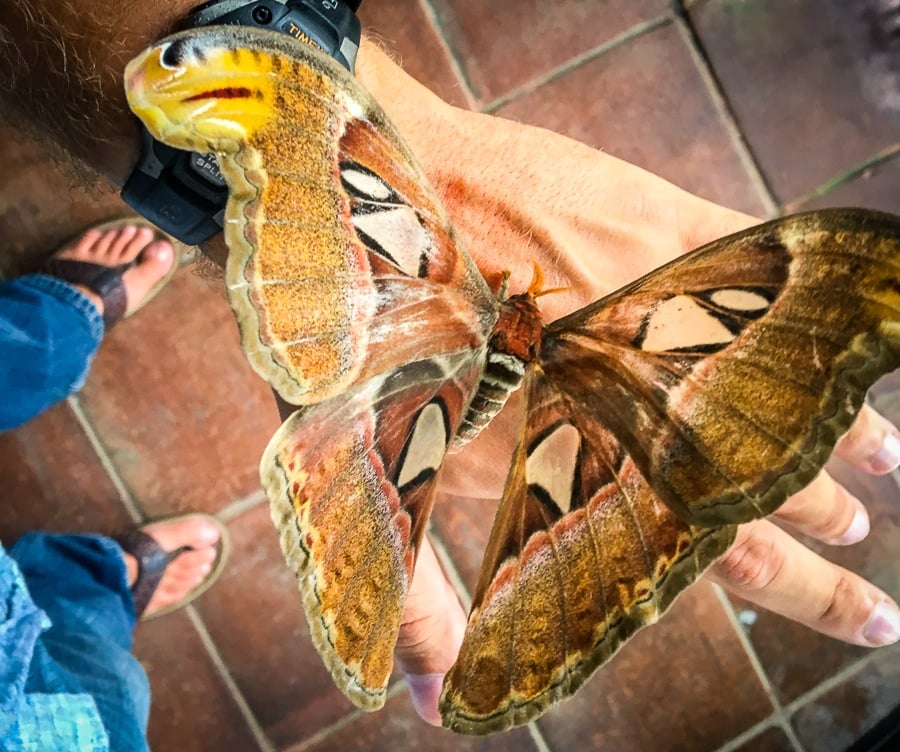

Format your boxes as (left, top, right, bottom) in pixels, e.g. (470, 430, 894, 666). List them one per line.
(0, 274, 150, 752)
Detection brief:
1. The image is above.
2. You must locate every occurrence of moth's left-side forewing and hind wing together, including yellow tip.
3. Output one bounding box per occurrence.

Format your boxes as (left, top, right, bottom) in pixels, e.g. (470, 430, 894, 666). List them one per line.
(126, 27, 498, 709)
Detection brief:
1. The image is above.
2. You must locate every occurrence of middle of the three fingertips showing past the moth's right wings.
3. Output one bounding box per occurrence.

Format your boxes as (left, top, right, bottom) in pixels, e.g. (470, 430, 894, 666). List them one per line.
(773, 470, 869, 546)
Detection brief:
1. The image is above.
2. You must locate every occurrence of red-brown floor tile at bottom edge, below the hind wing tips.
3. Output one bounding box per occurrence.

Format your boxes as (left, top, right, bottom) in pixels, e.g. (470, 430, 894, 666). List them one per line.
(306, 693, 537, 752)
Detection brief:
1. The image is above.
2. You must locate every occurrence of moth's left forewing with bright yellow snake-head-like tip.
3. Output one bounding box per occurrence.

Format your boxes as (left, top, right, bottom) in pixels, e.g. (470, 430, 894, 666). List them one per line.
(126, 27, 497, 405)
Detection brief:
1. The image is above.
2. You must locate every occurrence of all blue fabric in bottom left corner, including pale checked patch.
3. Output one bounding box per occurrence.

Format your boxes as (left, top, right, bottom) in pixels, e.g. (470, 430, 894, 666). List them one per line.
(0, 533, 150, 752)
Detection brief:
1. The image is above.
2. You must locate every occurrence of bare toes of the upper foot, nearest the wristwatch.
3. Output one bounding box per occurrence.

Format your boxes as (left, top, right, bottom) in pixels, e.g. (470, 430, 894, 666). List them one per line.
(55, 225, 175, 314)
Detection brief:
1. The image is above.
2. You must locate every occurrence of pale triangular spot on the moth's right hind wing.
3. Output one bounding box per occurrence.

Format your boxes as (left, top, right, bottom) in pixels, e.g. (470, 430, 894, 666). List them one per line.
(525, 423, 581, 514)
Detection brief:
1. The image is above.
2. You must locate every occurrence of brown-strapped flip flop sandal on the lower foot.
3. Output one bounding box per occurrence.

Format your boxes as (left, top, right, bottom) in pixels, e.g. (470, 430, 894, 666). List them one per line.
(113, 512, 231, 621)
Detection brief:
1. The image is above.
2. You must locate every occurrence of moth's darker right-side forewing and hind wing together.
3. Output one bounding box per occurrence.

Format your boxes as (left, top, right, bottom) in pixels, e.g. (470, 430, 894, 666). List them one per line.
(441, 210, 900, 734)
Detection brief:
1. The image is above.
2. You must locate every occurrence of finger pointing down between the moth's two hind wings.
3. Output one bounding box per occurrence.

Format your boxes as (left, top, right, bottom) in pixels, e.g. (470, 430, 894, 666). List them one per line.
(394, 538, 466, 726)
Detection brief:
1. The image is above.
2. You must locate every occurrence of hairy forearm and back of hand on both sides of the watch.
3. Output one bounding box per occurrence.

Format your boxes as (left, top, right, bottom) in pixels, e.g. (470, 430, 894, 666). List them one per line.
(0, 0, 748, 308)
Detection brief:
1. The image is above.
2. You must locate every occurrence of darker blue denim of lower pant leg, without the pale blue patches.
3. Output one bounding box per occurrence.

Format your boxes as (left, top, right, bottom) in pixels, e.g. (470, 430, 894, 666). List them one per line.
(9, 533, 150, 752)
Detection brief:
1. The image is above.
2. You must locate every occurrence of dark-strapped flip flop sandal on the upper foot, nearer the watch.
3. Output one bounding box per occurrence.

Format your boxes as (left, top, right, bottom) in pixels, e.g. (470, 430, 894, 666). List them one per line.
(40, 216, 185, 331)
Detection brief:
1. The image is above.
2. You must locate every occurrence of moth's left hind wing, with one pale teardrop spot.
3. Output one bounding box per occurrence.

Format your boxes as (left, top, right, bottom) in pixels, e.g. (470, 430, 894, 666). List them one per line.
(261, 358, 481, 710)
